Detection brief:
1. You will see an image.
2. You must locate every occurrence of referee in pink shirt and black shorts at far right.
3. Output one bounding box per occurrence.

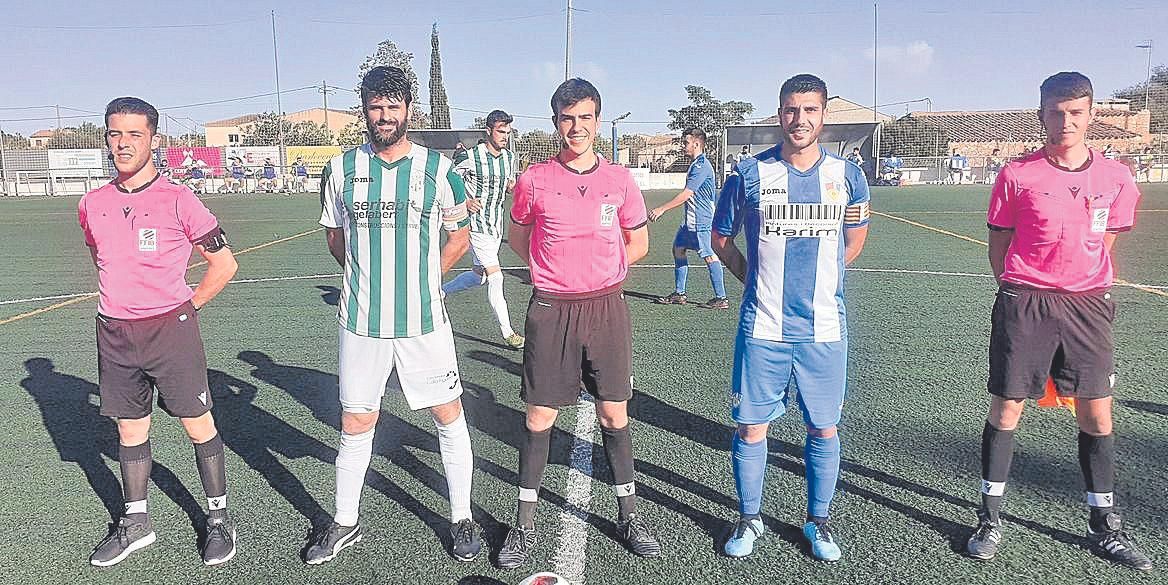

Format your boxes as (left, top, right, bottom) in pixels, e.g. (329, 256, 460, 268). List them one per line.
(967, 71, 1152, 571)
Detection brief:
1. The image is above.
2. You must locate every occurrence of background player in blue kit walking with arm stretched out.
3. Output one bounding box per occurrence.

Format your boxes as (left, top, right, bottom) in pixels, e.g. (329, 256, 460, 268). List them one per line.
(649, 128, 730, 308)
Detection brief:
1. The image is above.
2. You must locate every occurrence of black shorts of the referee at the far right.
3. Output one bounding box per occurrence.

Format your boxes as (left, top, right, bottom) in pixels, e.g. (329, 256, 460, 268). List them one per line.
(989, 284, 1115, 399)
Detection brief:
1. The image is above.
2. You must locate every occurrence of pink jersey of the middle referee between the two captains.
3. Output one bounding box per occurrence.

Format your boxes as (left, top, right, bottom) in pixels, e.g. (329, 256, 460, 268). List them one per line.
(512, 158, 648, 294)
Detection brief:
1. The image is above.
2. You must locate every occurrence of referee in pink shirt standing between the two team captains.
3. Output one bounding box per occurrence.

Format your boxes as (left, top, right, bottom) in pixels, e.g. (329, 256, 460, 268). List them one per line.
(499, 78, 661, 569)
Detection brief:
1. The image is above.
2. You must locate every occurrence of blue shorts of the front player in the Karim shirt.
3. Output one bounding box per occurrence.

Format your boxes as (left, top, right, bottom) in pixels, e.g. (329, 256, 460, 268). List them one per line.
(730, 334, 848, 429)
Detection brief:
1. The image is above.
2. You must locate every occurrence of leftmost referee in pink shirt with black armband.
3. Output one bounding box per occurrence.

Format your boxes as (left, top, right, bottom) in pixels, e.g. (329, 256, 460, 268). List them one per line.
(77, 97, 236, 566)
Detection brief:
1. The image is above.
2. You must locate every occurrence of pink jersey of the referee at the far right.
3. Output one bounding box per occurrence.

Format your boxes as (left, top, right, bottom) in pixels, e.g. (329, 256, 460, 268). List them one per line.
(987, 149, 1140, 292)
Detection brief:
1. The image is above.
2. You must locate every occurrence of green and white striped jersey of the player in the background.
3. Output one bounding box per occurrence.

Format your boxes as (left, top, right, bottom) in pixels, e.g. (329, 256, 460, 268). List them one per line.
(456, 144, 515, 237)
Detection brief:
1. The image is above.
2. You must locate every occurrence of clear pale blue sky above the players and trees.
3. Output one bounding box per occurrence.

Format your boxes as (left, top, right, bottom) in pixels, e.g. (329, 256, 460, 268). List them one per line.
(0, 0, 1168, 135)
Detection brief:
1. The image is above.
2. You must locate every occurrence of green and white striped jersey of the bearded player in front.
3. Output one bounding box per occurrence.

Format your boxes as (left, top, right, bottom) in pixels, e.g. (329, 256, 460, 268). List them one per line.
(320, 144, 468, 337)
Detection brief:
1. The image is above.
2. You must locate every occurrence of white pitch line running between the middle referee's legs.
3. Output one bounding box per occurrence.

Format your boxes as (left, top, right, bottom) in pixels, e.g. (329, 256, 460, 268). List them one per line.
(551, 398, 596, 585)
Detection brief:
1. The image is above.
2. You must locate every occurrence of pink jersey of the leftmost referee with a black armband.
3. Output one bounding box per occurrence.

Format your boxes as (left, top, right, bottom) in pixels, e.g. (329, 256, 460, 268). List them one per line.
(77, 176, 218, 319)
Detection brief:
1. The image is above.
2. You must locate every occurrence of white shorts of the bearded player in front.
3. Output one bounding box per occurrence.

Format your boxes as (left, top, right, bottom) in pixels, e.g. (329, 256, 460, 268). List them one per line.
(338, 323, 463, 412)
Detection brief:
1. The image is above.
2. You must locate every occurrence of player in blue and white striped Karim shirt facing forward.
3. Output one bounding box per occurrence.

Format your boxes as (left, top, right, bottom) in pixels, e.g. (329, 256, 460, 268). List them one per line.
(714, 74, 869, 560)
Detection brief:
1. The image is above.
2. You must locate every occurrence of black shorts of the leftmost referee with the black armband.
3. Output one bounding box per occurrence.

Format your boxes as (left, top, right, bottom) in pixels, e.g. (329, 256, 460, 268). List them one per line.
(97, 301, 211, 418)
